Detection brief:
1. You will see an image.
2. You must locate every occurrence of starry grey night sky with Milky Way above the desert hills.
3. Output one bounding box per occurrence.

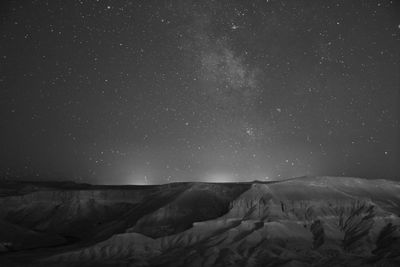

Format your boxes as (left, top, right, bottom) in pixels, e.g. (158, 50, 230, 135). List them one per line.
(0, 0, 400, 184)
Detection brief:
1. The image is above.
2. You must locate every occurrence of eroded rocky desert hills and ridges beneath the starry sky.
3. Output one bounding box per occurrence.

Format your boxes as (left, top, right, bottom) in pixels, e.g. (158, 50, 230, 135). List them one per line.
(0, 177, 400, 267)
